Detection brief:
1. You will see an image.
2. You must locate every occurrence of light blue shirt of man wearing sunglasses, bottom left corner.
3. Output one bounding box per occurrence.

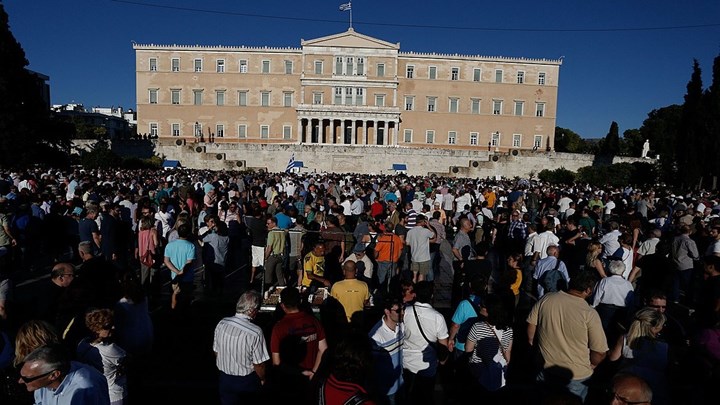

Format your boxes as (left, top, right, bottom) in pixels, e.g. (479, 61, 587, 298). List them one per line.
(34, 361, 110, 405)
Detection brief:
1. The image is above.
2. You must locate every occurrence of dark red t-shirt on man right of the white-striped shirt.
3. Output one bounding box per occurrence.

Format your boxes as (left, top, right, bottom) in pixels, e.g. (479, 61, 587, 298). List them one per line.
(270, 311, 325, 370)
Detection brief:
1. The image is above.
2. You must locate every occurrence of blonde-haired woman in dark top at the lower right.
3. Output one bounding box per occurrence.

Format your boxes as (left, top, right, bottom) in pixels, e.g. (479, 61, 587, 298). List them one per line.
(609, 307, 669, 404)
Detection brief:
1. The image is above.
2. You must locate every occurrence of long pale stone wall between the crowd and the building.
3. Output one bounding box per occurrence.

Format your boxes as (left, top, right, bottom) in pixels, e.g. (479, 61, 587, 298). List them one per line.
(80, 139, 652, 177)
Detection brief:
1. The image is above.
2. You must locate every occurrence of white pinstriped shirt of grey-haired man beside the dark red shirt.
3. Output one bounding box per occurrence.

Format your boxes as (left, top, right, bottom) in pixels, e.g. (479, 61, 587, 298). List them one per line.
(213, 314, 270, 376)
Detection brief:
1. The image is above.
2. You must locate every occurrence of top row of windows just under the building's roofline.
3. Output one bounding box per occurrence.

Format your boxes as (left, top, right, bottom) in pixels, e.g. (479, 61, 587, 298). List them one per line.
(148, 56, 545, 86)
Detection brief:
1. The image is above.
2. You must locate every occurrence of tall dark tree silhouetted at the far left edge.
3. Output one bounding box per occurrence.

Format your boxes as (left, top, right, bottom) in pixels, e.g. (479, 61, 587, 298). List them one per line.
(0, 3, 69, 166)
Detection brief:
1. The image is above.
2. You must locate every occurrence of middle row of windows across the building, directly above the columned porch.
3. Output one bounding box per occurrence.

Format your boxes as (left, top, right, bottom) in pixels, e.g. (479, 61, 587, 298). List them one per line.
(148, 87, 545, 117)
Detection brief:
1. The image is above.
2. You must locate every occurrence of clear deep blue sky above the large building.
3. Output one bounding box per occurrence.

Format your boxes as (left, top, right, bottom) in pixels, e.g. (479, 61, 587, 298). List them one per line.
(3, 0, 720, 138)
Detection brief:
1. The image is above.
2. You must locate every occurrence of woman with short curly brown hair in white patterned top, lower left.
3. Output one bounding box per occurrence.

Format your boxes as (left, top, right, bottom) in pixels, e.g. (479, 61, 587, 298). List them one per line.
(77, 308, 127, 405)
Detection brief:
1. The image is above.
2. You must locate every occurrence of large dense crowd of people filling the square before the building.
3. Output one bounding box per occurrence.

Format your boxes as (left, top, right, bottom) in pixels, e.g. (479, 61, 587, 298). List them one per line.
(0, 169, 720, 405)
